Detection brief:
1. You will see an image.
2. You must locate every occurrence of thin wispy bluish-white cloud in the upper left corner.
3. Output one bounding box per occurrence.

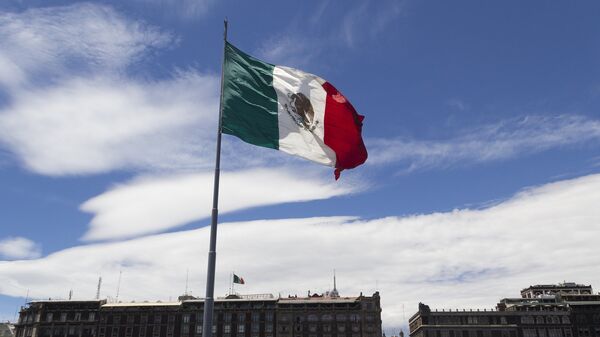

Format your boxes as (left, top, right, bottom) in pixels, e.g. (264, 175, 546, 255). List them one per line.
(0, 3, 174, 84)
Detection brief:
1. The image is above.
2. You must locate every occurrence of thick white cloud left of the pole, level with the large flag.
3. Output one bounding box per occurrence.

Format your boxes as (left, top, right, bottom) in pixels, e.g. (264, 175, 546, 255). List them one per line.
(0, 72, 218, 175)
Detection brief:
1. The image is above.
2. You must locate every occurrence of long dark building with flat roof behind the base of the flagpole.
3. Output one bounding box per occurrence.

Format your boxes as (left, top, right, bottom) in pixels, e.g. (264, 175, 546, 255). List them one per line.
(15, 291, 382, 337)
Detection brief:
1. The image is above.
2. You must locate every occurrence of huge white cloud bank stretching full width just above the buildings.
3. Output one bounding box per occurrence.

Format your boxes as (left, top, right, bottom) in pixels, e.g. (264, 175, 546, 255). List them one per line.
(0, 175, 600, 327)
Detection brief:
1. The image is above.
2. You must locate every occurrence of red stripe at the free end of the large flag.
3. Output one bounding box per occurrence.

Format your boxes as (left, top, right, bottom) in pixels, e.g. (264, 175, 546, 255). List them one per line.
(323, 82, 367, 180)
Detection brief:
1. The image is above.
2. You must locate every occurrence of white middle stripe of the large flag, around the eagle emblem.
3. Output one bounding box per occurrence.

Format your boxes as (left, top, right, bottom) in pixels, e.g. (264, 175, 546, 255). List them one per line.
(273, 66, 336, 167)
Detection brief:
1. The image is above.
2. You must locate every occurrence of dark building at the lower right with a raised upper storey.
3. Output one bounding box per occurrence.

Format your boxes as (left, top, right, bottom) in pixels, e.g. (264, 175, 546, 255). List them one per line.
(409, 282, 600, 337)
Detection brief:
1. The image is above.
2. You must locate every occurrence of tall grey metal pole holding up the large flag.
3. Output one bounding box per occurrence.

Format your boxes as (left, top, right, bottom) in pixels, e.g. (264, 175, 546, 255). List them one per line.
(202, 19, 227, 337)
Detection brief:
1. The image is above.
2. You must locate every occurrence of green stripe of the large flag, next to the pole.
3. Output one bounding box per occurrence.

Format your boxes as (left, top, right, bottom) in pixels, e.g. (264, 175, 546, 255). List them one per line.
(222, 43, 279, 149)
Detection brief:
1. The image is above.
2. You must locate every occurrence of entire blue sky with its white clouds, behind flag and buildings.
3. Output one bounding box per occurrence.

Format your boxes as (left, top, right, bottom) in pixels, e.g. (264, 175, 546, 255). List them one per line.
(0, 0, 600, 331)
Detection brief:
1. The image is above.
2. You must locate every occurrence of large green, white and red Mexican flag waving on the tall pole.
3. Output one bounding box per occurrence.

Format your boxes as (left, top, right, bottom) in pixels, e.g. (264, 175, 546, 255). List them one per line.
(222, 43, 367, 179)
